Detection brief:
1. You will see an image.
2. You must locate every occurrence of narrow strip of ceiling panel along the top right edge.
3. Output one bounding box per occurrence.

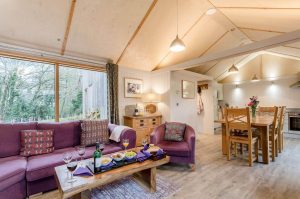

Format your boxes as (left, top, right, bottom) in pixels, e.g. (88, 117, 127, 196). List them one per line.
(210, 0, 300, 8)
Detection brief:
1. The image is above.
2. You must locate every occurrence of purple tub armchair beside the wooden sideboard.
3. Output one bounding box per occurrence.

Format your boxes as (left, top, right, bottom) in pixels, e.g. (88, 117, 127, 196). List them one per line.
(150, 124, 195, 170)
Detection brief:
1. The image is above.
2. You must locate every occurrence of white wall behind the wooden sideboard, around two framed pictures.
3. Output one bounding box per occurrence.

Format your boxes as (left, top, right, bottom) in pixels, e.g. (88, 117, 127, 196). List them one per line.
(119, 67, 214, 133)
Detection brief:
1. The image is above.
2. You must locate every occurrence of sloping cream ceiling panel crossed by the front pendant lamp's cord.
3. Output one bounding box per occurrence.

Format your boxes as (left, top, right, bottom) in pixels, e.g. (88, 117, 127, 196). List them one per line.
(119, 0, 211, 71)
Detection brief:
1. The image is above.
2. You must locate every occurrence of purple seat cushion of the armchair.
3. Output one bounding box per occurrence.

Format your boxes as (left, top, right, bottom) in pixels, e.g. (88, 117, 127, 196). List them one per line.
(158, 141, 190, 157)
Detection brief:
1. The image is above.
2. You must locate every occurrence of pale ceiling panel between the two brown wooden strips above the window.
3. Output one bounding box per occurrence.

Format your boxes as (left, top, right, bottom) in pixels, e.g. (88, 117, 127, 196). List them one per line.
(65, 0, 152, 61)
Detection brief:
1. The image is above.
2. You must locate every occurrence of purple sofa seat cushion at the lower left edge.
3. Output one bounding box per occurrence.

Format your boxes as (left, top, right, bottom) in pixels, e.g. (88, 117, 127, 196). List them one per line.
(0, 156, 27, 191)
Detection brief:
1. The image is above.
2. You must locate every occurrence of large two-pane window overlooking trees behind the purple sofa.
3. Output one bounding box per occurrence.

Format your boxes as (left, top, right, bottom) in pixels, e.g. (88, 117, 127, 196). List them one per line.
(0, 57, 107, 122)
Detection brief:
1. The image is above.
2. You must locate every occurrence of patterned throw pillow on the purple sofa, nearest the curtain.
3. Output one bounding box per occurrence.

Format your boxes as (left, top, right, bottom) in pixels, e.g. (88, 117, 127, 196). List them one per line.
(81, 120, 109, 146)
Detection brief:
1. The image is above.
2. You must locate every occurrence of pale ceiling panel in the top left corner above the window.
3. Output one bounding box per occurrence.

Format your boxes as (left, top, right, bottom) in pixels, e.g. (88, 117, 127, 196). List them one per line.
(0, 0, 71, 53)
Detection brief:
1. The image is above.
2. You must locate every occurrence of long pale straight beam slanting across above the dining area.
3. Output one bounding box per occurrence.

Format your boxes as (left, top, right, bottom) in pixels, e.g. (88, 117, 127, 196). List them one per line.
(158, 30, 300, 71)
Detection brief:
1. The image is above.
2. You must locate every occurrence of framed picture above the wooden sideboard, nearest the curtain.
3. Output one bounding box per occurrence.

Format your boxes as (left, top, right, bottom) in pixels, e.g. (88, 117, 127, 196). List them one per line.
(124, 78, 143, 98)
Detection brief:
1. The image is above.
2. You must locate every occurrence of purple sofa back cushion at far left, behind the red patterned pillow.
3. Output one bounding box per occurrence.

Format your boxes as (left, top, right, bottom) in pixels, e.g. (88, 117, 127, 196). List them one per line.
(0, 122, 37, 158)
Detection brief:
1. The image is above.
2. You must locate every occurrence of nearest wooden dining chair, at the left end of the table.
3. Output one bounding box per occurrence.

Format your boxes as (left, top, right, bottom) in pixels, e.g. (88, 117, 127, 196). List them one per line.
(225, 107, 258, 166)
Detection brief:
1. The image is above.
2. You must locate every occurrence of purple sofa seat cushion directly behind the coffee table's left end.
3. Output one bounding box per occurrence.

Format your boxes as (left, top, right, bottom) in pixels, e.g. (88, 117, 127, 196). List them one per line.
(26, 147, 77, 181)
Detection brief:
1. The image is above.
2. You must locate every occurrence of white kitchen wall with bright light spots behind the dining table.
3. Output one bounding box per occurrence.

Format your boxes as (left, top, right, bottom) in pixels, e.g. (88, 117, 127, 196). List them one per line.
(224, 77, 300, 108)
